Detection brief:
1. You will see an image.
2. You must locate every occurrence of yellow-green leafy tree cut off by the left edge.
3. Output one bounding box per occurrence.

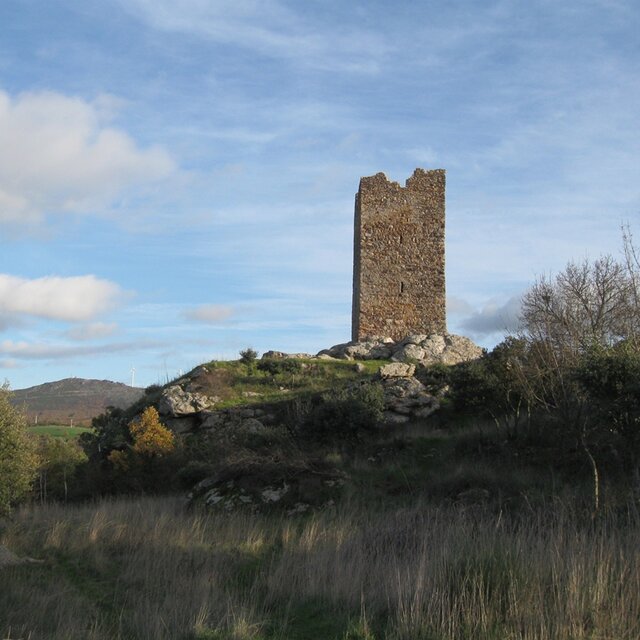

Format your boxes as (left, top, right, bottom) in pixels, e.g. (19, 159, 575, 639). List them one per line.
(0, 384, 38, 515)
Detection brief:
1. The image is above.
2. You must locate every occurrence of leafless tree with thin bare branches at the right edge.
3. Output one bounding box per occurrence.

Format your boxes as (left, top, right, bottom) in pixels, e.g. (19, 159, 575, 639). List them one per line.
(521, 240, 640, 513)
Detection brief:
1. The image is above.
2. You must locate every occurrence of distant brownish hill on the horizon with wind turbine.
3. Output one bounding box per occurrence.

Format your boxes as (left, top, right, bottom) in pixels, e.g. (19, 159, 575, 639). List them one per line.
(11, 378, 144, 425)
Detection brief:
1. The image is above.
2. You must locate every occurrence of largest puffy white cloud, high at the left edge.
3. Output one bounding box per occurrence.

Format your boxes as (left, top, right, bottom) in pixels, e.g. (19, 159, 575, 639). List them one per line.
(0, 91, 174, 224)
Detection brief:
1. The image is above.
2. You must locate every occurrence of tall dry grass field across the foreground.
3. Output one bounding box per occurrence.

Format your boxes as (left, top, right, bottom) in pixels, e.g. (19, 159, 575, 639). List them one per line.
(0, 498, 640, 640)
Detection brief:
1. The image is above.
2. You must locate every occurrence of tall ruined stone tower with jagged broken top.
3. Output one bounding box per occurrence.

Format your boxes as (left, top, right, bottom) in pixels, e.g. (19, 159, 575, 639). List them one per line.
(351, 169, 446, 340)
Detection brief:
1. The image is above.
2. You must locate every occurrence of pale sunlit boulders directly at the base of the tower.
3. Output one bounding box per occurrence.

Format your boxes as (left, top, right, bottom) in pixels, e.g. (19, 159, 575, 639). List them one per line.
(317, 334, 482, 366)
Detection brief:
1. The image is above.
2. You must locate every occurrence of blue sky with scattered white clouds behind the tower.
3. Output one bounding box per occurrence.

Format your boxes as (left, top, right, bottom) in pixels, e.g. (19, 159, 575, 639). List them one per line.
(0, 0, 640, 389)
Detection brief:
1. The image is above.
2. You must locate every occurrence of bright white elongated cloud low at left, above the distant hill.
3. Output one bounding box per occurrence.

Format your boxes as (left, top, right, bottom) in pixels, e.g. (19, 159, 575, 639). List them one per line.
(0, 274, 125, 322)
